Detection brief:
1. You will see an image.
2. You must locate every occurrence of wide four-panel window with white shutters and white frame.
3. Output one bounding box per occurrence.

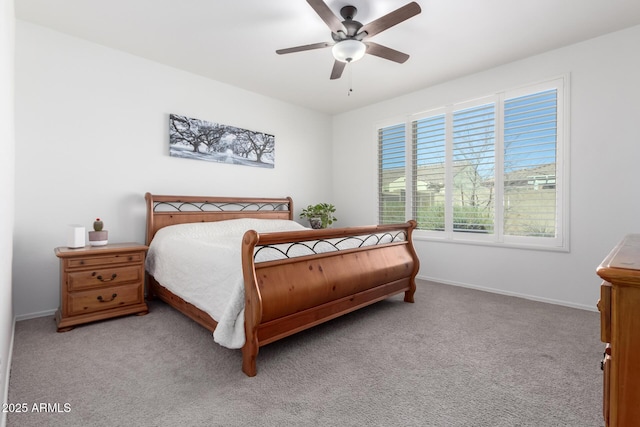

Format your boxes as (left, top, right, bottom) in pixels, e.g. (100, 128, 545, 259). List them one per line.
(378, 78, 568, 249)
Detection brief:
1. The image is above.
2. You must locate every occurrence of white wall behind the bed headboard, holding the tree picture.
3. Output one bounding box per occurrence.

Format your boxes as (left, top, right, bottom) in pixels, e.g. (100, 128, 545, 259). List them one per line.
(13, 20, 332, 319)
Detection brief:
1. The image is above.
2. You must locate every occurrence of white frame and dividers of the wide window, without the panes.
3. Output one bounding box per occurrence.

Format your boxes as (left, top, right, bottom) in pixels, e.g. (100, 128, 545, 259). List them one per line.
(376, 74, 570, 252)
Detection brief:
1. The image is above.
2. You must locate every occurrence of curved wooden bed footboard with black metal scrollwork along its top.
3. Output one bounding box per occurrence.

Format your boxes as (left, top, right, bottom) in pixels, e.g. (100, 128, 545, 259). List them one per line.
(242, 221, 419, 376)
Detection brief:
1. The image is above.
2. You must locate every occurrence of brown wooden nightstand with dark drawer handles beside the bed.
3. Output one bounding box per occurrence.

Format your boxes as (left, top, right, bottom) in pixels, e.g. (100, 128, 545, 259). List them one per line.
(55, 243, 149, 332)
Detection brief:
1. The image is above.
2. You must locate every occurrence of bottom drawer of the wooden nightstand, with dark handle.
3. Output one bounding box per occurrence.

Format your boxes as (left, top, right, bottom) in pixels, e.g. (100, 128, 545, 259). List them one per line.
(68, 283, 143, 315)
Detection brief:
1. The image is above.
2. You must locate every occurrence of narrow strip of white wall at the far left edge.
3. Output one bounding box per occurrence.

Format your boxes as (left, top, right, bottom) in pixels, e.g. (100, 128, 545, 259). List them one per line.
(0, 0, 15, 426)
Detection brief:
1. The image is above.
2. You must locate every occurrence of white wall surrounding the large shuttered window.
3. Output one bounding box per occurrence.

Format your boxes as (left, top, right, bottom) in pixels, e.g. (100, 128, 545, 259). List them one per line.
(333, 26, 640, 310)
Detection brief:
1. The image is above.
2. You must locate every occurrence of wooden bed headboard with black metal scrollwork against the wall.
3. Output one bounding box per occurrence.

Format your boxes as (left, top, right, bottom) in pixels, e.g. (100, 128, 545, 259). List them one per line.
(144, 193, 293, 245)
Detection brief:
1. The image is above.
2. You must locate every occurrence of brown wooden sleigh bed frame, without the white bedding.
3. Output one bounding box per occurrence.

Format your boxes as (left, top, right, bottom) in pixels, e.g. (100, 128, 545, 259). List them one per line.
(145, 193, 419, 376)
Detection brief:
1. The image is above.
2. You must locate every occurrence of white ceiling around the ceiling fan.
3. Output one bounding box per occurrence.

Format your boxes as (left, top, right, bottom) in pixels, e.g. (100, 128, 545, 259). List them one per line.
(15, 0, 640, 114)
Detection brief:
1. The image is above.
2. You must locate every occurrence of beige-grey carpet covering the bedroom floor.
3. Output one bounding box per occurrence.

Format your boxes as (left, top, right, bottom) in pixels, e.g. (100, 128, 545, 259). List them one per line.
(8, 282, 603, 427)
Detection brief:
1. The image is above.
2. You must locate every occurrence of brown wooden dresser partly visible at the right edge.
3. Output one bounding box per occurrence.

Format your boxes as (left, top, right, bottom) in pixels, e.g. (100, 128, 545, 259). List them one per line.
(597, 234, 640, 427)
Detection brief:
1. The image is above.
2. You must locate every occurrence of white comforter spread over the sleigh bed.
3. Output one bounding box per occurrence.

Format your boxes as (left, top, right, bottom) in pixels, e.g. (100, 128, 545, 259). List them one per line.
(146, 218, 305, 348)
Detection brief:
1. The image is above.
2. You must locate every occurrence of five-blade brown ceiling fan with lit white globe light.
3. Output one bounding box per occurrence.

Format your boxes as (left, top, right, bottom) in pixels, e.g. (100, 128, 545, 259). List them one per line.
(276, 0, 422, 80)
